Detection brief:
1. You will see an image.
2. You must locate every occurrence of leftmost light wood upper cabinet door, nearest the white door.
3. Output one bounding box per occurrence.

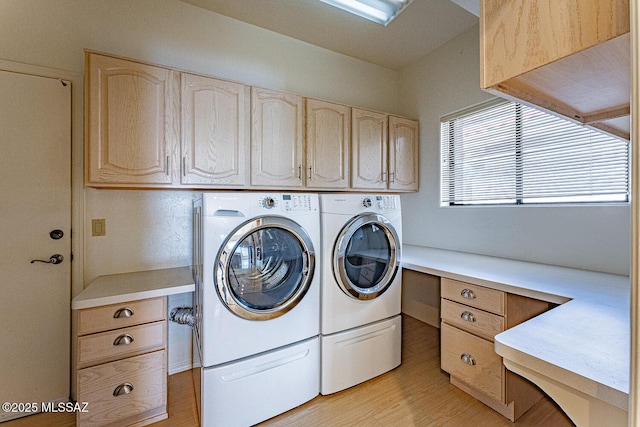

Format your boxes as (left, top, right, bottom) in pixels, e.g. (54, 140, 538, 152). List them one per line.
(85, 53, 178, 187)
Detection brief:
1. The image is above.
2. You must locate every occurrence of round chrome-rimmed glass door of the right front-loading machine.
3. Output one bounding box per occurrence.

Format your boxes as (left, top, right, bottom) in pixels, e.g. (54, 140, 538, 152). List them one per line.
(333, 214, 400, 299)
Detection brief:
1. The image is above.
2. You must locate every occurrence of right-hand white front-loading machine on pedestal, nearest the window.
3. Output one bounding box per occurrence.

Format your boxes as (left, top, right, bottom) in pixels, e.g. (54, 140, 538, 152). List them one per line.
(320, 194, 402, 395)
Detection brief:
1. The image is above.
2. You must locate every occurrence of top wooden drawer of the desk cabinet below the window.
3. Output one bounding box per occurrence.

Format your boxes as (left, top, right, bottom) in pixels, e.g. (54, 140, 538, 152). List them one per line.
(440, 277, 505, 315)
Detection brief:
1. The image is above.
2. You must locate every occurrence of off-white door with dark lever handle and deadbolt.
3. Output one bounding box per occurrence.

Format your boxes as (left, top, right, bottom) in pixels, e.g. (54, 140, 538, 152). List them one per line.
(0, 71, 71, 421)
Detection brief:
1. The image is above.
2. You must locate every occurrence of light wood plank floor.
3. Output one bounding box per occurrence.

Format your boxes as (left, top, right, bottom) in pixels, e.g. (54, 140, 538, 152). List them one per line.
(2, 316, 573, 427)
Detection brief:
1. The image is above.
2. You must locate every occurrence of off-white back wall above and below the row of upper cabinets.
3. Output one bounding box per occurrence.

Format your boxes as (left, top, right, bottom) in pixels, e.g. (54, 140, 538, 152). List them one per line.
(0, 0, 398, 371)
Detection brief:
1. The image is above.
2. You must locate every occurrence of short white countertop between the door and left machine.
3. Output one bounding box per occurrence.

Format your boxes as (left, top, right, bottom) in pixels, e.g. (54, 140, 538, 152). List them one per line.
(71, 267, 195, 310)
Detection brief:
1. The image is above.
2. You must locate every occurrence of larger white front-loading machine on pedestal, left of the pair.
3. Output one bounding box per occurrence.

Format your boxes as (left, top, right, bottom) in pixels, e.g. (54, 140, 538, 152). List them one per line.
(193, 193, 321, 427)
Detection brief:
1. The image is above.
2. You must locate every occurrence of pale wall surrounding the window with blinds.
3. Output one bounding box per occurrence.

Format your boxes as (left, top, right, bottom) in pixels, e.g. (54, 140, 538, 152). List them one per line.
(400, 26, 630, 275)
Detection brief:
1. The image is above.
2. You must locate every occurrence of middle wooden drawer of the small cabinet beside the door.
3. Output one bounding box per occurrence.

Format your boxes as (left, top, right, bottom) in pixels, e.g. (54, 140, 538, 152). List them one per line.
(78, 320, 167, 368)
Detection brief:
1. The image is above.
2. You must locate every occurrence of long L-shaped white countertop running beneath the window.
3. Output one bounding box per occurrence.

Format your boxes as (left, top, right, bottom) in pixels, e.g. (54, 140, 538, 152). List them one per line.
(402, 245, 631, 410)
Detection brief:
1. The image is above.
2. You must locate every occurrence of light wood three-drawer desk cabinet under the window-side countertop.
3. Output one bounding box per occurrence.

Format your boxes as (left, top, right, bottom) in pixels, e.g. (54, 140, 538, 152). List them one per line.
(440, 278, 554, 421)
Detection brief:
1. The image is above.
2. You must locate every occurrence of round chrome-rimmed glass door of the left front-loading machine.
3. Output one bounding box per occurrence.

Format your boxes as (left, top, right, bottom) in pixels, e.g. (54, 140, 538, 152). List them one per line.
(215, 217, 314, 320)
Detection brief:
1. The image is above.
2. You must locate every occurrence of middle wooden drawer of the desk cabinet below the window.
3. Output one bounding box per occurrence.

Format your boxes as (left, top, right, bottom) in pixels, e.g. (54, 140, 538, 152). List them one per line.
(440, 298, 504, 341)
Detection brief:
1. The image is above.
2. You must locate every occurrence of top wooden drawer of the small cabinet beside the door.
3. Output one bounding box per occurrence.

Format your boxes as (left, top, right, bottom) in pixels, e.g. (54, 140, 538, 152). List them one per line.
(78, 297, 167, 335)
